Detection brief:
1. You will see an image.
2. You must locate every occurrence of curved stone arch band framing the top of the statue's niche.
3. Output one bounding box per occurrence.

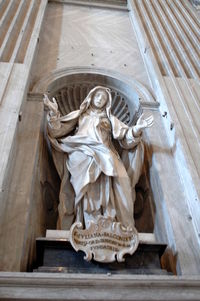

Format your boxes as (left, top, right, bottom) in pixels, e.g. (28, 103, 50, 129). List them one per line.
(31, 67, 156, 108)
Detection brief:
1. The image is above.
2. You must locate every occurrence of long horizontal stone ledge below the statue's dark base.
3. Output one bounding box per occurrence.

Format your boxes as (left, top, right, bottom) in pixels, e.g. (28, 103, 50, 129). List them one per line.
(0, 272, 200, 301)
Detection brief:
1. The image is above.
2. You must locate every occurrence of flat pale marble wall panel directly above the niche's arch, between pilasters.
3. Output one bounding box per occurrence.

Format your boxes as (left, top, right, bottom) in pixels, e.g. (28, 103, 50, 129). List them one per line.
(31, 2, 150, 91)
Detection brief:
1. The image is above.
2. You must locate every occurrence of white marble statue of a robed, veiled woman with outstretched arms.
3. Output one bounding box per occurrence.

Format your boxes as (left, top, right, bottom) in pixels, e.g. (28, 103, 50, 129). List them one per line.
(44, 86, 153, 230)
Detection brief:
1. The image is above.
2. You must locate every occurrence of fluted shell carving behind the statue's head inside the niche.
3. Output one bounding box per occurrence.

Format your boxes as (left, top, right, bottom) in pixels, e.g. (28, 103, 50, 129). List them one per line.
(53, 84, 132, 125)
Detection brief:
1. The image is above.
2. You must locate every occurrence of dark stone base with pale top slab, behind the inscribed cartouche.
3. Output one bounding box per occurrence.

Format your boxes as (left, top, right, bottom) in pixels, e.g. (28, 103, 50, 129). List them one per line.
(34, 231, 167, 275)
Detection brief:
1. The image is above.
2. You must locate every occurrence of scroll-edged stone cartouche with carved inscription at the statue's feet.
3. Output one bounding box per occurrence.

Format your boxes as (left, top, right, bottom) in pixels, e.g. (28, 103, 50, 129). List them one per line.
(69, 217, 139, 262)
